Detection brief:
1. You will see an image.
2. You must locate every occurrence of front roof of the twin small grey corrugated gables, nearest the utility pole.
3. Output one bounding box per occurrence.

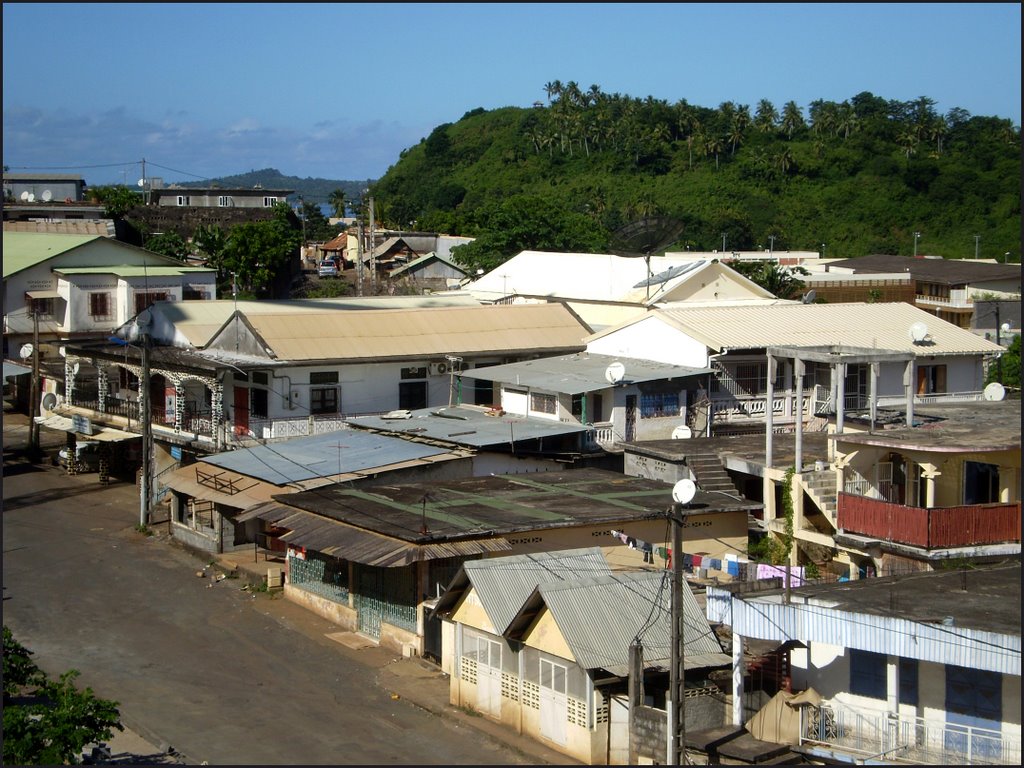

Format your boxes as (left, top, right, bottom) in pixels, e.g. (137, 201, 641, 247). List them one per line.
(516, 570, 731, 675)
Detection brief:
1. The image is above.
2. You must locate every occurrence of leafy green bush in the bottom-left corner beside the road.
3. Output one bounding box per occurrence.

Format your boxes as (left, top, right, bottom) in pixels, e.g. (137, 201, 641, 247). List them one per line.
(3, 627, 124, 765)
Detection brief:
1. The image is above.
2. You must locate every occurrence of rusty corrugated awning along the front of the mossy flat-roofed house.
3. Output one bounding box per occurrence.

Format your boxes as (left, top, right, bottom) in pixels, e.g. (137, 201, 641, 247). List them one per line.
(236, 502, 512, 567)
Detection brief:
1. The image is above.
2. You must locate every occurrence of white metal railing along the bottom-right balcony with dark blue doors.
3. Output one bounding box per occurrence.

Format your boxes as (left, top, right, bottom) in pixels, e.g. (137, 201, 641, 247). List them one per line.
(800, 705, 1021, 765)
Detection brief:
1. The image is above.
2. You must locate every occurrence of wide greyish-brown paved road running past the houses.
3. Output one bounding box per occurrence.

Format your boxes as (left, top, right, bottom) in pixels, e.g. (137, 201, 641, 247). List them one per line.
(3, 424, 524, 765)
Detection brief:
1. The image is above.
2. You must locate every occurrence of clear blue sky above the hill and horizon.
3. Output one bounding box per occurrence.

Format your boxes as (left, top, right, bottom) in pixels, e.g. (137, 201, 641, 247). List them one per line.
(3, 2, 1021, 184)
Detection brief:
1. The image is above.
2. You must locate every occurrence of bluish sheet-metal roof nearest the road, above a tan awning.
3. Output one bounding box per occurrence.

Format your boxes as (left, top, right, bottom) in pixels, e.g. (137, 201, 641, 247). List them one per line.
(204, 429, 451, 485)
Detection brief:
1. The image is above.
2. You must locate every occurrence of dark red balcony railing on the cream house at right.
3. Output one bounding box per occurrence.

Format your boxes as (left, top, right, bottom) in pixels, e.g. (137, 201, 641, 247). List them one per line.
(838, 495, 1021, 549)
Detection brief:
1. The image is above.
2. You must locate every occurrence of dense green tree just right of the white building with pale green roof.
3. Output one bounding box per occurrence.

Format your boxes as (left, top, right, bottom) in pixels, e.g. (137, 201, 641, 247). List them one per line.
(222, 203, 302, 296)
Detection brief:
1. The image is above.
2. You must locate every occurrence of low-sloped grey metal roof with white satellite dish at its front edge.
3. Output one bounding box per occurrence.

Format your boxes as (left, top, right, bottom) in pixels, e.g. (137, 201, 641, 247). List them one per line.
(463, 352, 711, 394)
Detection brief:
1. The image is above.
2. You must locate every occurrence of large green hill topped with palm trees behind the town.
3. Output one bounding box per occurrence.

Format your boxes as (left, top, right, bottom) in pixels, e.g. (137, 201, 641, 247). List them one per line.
(371, 82, 1021, 266)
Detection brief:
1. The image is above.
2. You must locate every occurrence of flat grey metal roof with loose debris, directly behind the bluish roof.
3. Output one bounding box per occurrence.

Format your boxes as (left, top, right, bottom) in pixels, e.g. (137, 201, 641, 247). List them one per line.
(349, 406, 589, 447)
